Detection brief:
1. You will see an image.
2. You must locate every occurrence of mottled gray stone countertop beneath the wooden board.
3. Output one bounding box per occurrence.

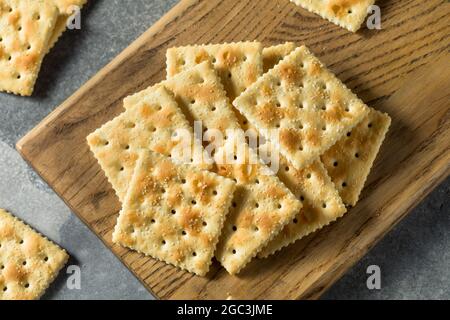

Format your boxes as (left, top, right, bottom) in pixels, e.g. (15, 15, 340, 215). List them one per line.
(0, 0, 450, 299)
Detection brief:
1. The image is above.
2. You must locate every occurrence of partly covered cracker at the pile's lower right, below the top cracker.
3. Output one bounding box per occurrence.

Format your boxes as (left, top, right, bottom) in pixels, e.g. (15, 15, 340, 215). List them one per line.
(258, 157, 346, 258)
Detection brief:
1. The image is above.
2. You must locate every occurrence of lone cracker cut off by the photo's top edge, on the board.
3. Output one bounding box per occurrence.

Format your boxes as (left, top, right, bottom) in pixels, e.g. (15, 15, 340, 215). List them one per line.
(291, 0, 375, 32)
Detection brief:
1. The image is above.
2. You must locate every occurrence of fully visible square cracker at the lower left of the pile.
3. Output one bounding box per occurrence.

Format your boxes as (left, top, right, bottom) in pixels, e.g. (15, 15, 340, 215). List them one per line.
(113, 151, 236, 276)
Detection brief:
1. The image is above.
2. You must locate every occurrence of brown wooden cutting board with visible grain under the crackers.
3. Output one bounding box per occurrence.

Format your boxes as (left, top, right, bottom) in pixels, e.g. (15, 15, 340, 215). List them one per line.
(17, 0, 450, 299)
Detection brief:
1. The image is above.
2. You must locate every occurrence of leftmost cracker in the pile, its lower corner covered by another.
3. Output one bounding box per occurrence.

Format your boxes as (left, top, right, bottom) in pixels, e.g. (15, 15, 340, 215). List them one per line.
(87, 86, 210, 202)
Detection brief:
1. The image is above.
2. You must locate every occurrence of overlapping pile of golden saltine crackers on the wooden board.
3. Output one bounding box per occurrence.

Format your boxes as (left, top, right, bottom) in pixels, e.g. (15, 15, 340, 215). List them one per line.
(87, 42, 390, 276)
